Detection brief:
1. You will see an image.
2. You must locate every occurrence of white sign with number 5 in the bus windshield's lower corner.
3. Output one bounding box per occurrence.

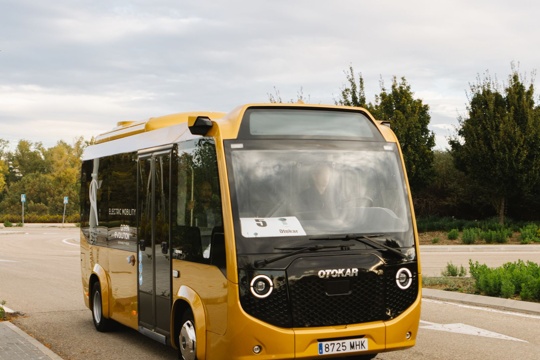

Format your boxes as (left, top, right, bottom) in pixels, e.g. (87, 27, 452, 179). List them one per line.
(240, 216, 306, 238)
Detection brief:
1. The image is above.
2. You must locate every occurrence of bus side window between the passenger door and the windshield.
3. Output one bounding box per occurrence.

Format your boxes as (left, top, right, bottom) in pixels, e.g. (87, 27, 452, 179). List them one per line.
(172, 138, 223, 263)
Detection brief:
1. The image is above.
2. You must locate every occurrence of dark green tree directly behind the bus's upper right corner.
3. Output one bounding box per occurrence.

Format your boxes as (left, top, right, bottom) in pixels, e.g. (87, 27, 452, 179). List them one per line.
(336, 66, 435, 191)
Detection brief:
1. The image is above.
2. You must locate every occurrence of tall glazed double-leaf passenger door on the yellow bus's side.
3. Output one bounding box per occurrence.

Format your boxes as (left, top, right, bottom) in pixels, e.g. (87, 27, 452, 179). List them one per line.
(138, 149, 172, 343)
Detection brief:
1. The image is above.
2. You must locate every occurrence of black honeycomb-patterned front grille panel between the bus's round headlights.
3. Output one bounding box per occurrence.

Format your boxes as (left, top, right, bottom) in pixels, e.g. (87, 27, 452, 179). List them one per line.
(240, 263, 418, 328)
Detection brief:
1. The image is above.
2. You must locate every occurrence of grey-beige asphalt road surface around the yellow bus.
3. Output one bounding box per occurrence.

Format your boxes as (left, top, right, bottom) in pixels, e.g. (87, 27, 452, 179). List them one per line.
(0, 225, 540, 360)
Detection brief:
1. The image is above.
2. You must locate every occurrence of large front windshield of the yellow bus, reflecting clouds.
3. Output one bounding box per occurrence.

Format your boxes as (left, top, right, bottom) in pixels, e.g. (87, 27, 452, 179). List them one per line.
(228, 139, 414, 252)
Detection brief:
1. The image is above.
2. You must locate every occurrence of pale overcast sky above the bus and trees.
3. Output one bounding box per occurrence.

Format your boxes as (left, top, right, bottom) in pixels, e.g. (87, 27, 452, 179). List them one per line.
(0, 0, 540, 149)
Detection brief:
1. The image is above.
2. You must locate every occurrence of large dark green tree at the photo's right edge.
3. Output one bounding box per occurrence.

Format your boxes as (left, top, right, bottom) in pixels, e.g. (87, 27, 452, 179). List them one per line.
(450, 69, 540, 223)
